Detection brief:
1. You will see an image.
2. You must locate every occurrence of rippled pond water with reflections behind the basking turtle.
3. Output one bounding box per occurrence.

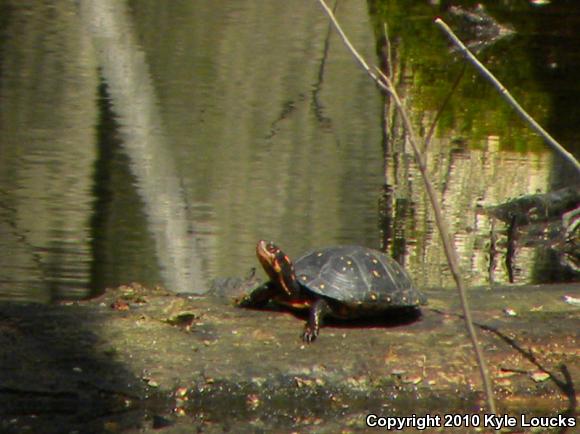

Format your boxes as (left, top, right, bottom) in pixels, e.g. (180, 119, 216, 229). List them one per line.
(0, 0, 580, 301)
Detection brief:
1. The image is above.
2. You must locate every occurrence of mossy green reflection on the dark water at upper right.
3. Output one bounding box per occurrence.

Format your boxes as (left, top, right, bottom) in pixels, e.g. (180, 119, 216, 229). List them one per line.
(368, 0, 552, 151)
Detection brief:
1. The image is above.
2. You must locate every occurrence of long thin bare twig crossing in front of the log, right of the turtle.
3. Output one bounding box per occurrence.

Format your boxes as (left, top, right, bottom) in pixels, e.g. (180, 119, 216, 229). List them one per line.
(318, 0, 496, 414)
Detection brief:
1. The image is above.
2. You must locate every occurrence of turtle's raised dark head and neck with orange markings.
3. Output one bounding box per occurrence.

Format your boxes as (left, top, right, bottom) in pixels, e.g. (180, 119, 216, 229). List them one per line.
(256, 240, 300, 298)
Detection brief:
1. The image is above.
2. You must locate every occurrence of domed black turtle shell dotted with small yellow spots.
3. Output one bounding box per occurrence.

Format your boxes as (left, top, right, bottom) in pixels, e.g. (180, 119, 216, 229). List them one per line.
(295, 246, 427, 310)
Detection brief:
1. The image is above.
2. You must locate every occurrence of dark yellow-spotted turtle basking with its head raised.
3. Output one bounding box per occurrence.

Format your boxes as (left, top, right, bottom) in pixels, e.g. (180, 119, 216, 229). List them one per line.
(237, 240, 427, 343)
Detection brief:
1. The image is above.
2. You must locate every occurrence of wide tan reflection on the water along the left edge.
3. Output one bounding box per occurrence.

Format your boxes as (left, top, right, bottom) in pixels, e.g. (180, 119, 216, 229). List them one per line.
(0, 2, 98, 300)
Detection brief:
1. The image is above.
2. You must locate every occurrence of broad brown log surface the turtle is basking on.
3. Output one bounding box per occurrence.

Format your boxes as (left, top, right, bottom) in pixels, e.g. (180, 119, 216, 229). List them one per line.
(0, 284, 580, 433)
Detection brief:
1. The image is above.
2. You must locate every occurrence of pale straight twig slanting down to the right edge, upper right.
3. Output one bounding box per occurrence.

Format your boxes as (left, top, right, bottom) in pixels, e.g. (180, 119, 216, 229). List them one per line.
(435, 18, 580, 173)
